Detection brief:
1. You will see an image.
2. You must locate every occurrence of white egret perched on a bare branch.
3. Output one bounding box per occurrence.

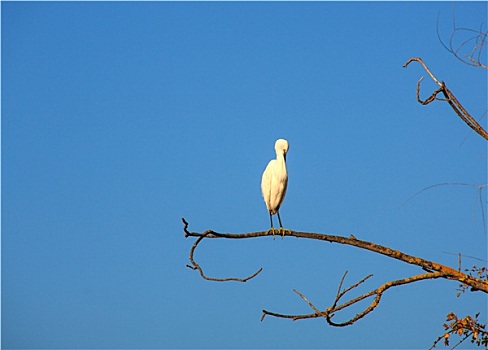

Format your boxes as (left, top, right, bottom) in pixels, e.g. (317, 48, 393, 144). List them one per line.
(261, 139, 289, 238)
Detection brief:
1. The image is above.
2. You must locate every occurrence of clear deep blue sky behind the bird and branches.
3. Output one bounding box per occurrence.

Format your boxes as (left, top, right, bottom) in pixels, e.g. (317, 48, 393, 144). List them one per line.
(1, 2, 487, 349)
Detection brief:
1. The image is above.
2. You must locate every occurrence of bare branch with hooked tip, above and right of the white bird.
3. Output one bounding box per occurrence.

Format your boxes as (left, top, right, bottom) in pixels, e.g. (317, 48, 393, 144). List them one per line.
(403, 57, 488, 140)
